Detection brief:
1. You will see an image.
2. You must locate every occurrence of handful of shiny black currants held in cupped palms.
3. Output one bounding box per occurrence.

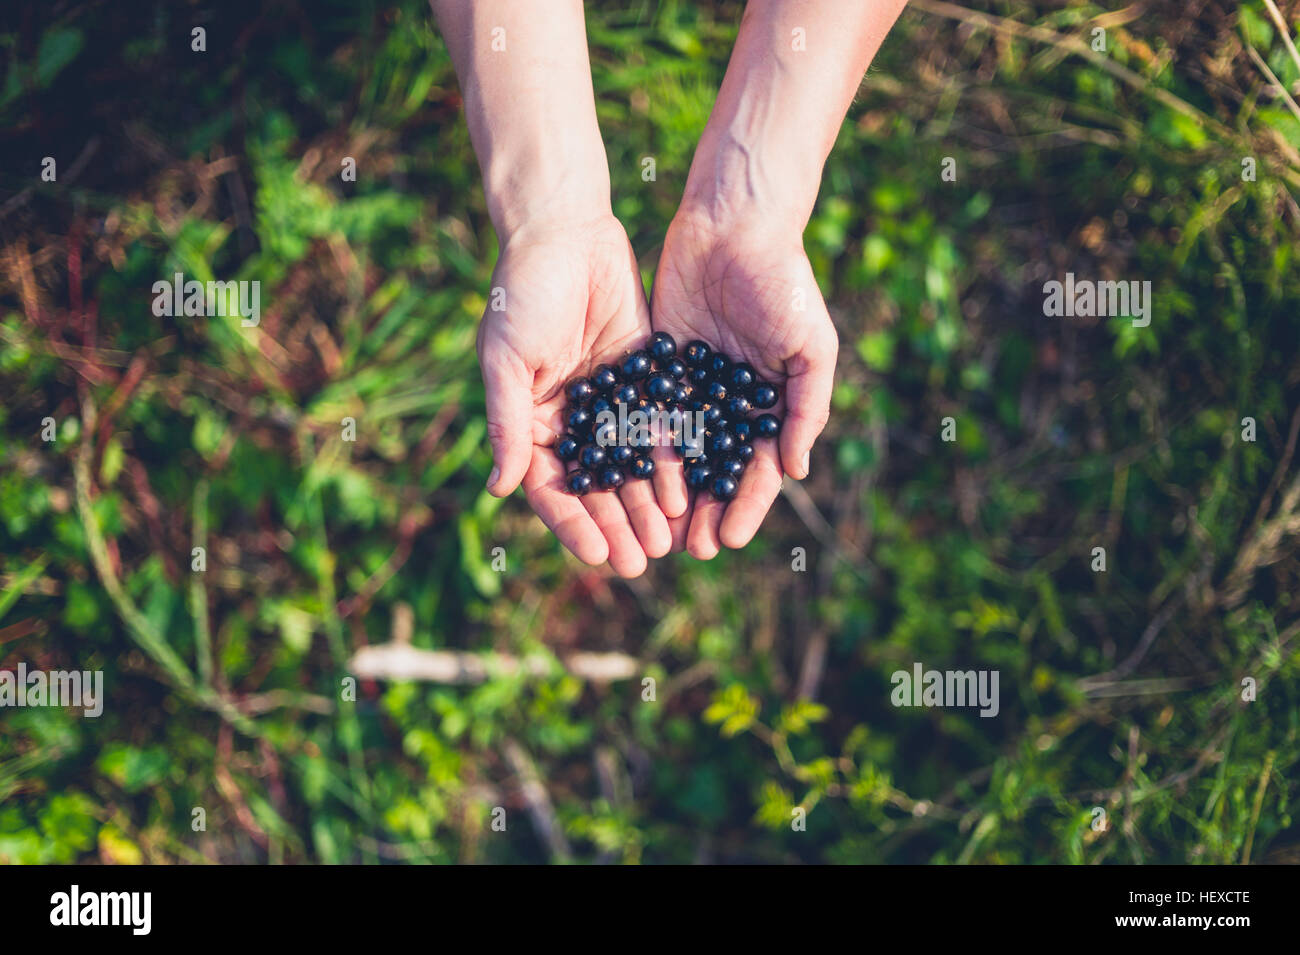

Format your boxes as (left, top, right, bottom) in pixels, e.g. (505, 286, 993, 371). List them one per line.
(555, 331, 781, 500)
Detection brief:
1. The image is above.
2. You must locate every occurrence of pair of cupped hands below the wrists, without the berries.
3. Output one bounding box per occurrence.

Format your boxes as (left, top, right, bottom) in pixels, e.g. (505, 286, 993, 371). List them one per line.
(478, 208, 839, 577)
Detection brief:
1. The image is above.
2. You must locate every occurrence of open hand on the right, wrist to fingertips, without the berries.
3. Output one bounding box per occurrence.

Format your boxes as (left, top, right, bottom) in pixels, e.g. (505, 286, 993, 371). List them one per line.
(651, 209, 839, 560)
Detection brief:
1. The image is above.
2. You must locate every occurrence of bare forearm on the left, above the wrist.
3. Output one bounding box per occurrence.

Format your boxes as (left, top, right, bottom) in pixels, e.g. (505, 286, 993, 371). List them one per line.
(430, 0, 610, 243)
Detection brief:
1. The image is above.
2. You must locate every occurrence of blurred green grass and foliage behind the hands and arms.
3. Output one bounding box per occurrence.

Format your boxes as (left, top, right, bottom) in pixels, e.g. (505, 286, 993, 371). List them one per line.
(0, 0, 1300, 863)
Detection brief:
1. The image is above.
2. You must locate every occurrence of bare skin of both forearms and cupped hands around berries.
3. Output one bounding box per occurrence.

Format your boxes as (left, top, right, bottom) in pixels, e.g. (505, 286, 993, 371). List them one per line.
(432, 0, 905, 577)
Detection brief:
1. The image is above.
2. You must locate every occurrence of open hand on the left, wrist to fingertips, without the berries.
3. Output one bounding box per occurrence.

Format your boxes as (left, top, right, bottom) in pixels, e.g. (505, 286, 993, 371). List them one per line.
(478, 216, 685, 577)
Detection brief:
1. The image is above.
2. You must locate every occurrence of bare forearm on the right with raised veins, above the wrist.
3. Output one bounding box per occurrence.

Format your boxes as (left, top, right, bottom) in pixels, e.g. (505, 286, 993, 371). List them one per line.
(683, 0, 906, 233)
